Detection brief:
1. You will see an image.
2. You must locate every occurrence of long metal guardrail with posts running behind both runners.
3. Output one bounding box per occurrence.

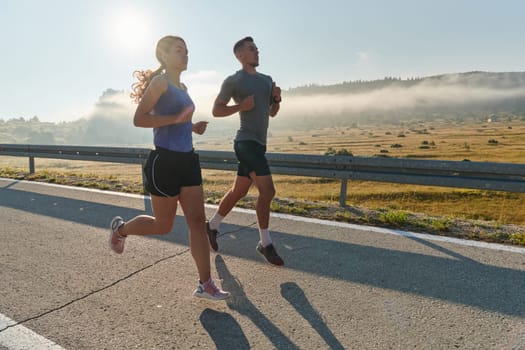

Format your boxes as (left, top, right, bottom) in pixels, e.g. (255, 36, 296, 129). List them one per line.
(0, 144, 525, 206)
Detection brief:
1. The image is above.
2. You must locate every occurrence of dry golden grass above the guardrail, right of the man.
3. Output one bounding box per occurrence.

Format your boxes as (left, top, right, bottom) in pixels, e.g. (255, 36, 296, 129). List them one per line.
(268, 117, 525, 163)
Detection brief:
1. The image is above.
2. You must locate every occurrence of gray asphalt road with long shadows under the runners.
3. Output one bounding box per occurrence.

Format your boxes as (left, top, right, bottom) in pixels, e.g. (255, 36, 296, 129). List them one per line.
(0, 179, 525, 350)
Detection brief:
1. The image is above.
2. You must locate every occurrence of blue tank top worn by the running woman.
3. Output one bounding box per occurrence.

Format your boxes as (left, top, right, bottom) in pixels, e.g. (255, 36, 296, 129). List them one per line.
(153, 82, 194, 152)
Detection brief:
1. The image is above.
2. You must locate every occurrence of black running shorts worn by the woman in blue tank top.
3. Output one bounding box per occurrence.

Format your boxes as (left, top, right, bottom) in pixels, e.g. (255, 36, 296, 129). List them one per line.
(143, 147, 202, 197)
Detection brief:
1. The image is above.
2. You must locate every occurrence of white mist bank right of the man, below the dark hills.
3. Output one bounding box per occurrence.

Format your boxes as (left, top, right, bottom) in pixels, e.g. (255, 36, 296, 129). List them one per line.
(283, 72, 525, 120)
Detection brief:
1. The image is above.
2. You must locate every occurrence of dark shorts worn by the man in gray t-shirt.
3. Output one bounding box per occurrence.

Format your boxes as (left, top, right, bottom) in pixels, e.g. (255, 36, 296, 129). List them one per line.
(233, 141, 271, 177)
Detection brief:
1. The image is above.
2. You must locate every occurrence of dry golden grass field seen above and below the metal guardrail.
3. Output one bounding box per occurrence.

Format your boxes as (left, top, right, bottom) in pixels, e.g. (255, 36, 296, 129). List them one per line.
(0, 120, 525, 230)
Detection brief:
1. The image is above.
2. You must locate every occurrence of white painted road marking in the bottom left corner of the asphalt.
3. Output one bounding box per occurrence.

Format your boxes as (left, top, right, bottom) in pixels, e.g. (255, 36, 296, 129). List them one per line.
(0, 314, 64, 350)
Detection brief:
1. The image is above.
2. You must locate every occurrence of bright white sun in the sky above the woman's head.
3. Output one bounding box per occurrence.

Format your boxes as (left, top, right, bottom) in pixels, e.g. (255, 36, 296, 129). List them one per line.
(109, 10, 150, 51)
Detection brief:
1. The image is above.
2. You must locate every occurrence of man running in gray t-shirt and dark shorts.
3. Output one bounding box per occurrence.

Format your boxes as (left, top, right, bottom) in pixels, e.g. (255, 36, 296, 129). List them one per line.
(206, 36, 284, 265)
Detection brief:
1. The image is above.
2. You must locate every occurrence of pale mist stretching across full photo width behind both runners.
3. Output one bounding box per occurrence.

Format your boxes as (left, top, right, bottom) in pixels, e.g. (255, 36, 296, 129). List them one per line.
(0, 72, 525, 145)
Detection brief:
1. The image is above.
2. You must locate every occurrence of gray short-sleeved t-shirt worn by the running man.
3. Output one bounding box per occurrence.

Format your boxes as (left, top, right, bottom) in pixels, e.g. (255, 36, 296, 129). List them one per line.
(218, 69, 272, 145)
